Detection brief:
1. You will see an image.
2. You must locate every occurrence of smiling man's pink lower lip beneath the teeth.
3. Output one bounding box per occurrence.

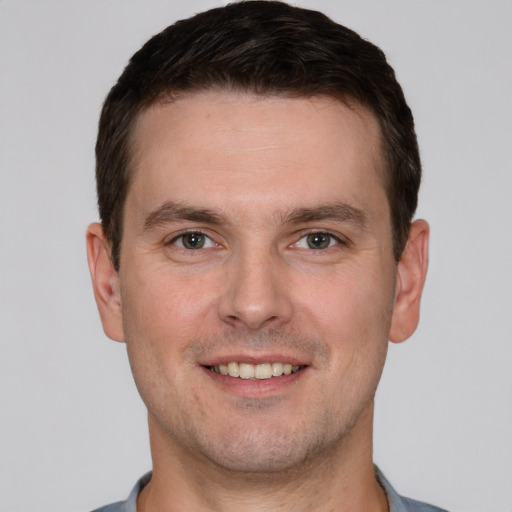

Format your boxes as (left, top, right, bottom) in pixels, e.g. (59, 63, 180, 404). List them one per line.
(203, 367, 308, 398)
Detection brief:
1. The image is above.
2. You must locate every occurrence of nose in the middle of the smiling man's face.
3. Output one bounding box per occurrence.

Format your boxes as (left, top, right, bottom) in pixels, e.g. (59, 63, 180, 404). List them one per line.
(218, 246, 293, 330)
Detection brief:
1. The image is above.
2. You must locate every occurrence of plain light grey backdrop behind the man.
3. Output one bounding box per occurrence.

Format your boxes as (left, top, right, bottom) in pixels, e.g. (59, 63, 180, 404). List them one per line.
(0, 0, 512, 512)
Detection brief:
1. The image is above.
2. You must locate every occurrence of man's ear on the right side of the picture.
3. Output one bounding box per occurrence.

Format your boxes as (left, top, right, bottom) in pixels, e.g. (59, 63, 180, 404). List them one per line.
(389, 220, 429, 343)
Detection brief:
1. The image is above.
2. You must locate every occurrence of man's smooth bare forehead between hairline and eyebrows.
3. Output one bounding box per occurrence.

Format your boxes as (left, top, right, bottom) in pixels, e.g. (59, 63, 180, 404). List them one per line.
(129, 91, 384, 222)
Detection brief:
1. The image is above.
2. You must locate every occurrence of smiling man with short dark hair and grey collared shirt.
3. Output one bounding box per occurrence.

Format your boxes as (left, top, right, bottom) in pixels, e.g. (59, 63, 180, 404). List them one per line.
(87, 2, 446, 512)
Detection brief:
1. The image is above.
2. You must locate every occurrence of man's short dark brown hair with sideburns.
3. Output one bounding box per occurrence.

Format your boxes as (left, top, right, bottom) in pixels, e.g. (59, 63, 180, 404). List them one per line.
(96, 0, 421, 270)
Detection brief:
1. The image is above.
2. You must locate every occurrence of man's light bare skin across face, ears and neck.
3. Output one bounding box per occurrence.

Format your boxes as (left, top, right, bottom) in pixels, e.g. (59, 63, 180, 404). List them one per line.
(87, 91, 428, 512)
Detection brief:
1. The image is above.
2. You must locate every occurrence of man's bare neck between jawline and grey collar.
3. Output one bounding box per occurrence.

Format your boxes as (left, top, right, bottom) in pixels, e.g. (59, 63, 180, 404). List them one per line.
(137, 405, 389, 512)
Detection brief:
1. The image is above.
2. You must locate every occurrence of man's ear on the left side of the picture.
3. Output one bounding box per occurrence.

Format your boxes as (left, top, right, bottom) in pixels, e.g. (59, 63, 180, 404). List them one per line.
(86, 222, 124, 341)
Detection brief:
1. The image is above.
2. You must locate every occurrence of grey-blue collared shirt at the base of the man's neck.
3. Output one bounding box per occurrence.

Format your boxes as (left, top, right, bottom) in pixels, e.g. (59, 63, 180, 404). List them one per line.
(93, 467, 447, 512)
